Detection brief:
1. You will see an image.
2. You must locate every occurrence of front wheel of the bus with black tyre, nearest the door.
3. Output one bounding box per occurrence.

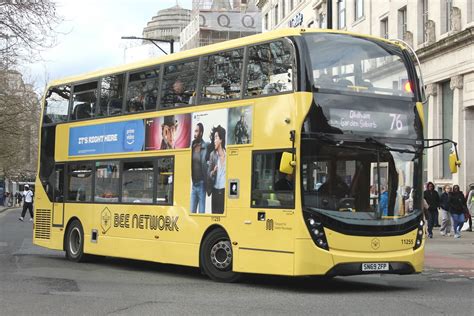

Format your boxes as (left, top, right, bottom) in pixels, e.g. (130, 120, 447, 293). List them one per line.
(200, 229, 240, 282)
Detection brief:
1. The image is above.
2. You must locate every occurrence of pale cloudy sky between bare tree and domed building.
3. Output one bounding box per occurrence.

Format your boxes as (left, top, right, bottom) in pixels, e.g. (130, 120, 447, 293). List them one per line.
(22, 0, 192, 93)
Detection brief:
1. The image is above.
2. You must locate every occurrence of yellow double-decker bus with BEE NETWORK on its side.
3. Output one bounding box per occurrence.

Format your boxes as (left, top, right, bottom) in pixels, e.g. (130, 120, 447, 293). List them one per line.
(33, 29, 448, 282)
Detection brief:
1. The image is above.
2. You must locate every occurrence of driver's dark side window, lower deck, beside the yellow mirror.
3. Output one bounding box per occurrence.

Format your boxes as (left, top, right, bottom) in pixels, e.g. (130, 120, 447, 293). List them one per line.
(251, 151, 295, 208)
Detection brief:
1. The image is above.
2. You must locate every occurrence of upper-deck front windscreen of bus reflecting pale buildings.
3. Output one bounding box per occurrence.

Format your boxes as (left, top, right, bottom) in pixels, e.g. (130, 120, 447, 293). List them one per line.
(304, 33, 414, 99)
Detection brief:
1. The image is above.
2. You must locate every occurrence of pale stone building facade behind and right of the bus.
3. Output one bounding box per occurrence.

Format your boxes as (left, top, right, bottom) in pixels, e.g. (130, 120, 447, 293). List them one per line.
(257, 0, 474, 191)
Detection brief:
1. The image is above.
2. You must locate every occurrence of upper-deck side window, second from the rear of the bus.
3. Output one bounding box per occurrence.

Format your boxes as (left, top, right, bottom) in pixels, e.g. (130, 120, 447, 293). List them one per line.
(71, 81, 97, 121)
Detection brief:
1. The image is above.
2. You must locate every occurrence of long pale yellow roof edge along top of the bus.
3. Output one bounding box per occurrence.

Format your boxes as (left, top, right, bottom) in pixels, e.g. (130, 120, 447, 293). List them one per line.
(48, 28, 401, 89)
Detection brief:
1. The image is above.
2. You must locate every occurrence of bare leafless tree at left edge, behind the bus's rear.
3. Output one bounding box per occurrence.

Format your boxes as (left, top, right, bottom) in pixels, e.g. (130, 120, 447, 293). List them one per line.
(0, 0, 62, 183)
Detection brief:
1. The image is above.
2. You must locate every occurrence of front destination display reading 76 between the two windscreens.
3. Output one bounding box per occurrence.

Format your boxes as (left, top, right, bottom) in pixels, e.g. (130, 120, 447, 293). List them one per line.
(329, 108, 408, 135)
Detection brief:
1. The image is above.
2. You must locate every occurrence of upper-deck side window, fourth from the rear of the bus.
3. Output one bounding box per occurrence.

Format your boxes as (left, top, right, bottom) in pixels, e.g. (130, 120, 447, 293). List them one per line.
(125, 69, 160, 113)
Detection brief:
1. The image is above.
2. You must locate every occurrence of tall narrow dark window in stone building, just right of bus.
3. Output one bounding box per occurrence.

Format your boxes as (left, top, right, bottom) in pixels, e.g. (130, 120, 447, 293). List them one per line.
(441, 81, 453, 179)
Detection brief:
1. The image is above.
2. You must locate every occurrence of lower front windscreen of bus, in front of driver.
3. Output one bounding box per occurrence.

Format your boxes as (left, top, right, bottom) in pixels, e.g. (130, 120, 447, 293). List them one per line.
(302, 139, 421, 218)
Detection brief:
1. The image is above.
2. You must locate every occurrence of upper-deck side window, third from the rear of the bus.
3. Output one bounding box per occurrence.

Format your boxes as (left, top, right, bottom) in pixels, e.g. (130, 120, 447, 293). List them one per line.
(99, 74, 125, 116)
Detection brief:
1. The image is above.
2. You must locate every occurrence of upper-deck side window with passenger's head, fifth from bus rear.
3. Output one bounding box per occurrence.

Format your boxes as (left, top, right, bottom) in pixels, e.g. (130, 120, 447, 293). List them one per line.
(160, 60, 199, 109)
